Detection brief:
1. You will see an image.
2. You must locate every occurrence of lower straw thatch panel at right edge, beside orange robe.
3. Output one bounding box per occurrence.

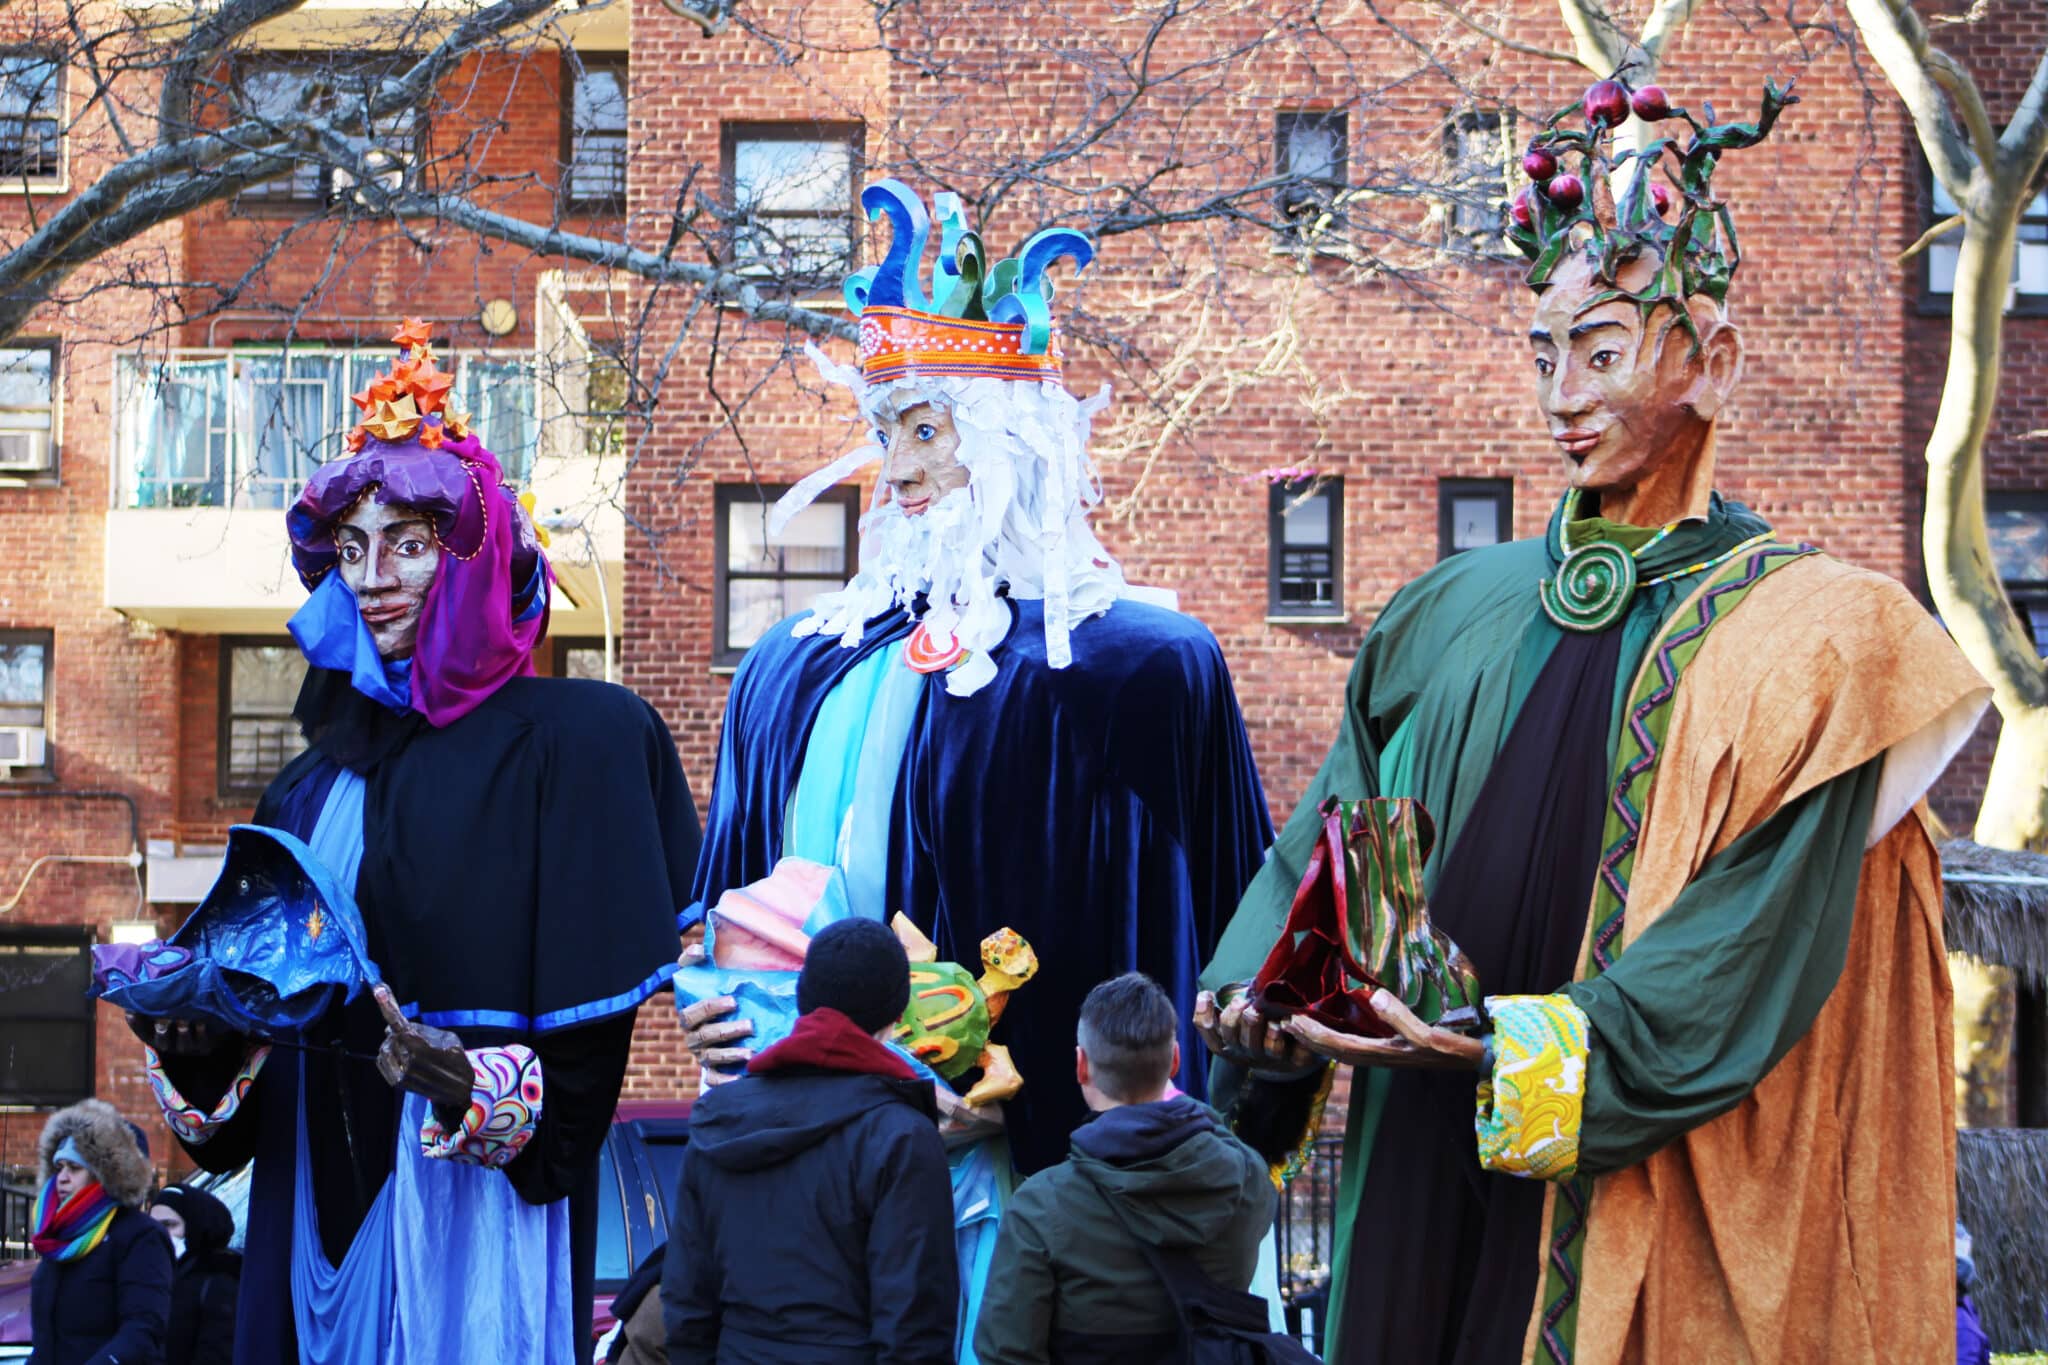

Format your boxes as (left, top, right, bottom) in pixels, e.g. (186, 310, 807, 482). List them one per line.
(1956, 1128, 2048, 1351)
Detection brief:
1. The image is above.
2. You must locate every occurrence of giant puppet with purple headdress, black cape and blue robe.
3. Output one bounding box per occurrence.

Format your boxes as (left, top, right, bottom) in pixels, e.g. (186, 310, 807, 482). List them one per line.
(114, 321, 698, 1365)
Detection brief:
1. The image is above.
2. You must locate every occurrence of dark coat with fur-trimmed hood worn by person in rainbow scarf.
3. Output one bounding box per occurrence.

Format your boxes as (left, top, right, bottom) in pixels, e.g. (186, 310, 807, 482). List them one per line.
(29, 1099, 170, 1365)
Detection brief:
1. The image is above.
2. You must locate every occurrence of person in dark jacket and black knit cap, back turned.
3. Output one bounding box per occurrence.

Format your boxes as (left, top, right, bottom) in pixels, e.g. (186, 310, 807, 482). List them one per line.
(662, 919, 961, 1365)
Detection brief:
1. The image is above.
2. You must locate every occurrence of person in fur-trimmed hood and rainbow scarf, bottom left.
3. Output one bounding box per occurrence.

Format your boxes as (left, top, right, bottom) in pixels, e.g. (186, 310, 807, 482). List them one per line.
(29, 1099, 170, 1365)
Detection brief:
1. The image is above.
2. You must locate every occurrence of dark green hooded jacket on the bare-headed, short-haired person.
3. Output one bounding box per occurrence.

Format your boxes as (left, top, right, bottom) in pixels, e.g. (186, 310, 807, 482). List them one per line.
(975, 1097, 1274, 1365)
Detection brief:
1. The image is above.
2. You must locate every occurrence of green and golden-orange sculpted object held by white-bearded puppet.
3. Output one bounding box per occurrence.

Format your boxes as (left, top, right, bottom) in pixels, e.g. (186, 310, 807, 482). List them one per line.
(889, 915, 1038, 1105)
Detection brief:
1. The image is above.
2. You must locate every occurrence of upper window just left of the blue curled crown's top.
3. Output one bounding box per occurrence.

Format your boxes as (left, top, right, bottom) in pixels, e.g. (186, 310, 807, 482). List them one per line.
(723, 123, 860, 287)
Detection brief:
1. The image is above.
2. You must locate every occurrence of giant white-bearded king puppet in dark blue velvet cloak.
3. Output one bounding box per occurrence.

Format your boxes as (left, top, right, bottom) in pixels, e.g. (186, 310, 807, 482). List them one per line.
(686, 180, 1272, 1236)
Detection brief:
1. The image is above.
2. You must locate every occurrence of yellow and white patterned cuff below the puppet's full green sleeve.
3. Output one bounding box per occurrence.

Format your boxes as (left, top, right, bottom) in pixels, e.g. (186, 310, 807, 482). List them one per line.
(1475, 995, 1587, 1181)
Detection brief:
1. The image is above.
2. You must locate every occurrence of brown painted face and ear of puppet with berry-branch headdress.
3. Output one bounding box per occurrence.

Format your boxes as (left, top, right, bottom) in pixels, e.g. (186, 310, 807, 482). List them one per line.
(1530, 256, 1741, 511)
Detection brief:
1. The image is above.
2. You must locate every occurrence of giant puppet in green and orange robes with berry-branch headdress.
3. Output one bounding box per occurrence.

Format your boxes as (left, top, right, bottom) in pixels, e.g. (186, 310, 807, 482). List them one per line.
(1198, 80, 1987, 1365)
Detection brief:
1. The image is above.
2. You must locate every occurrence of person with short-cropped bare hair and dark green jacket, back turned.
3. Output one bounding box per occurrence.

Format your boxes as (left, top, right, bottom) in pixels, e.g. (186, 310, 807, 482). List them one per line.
(975, 972, 1274, 1365)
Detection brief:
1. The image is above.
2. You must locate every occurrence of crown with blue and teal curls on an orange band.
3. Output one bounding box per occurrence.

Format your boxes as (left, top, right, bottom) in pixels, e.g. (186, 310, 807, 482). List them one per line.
(846, 180, 1096, 383)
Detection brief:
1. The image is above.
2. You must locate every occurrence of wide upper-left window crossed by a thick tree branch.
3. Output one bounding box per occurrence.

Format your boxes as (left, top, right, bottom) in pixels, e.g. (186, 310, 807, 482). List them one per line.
(236, 55, 422, 213)
